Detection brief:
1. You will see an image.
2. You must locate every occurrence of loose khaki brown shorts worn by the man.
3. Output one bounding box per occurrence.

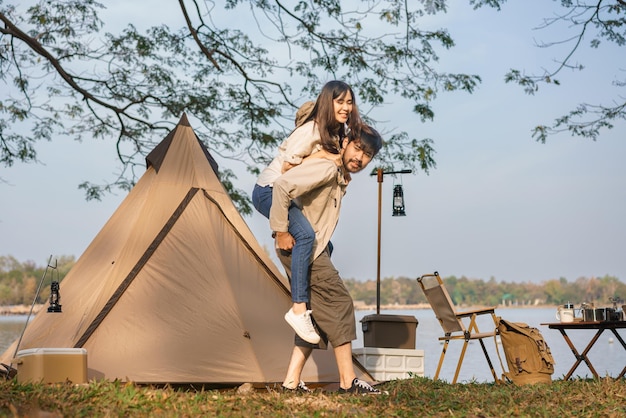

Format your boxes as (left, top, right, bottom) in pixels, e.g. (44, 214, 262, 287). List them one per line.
(277, 250, 356, 348)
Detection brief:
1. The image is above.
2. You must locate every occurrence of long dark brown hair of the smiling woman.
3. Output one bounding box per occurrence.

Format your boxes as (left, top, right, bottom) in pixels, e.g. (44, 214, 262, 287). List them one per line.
(305, 80, 361, 154)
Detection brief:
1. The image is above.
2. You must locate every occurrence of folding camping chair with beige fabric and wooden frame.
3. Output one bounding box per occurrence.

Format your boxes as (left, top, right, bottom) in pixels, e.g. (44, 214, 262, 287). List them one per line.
(417, 272, 500, 384)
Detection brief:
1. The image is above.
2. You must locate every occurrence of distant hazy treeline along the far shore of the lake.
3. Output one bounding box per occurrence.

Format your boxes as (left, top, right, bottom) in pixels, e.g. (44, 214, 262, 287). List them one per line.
(0, 256, 626, 307)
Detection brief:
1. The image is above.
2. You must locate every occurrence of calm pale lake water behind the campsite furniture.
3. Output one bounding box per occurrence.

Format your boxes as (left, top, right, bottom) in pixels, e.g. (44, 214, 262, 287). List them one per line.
(0, 308, 626, 382)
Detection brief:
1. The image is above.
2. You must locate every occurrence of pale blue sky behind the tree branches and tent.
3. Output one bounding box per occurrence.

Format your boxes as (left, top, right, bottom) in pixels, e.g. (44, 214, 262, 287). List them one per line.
(0, 0, 626, 283)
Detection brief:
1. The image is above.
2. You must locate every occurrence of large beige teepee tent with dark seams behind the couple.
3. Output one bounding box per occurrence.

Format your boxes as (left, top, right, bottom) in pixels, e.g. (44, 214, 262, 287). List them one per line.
(0, 115, 371, 384)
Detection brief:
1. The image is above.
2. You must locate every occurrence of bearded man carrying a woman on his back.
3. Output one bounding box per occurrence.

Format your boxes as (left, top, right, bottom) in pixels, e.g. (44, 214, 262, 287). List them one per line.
(270, 126, 382, 394)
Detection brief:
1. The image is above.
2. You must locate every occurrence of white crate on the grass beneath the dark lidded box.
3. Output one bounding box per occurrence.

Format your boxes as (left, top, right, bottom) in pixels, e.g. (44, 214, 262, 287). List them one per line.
(352, 347, 424, 382)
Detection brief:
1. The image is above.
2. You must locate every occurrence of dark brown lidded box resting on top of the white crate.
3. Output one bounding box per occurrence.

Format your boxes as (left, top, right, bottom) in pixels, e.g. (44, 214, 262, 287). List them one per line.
(361, 314, 417, 350)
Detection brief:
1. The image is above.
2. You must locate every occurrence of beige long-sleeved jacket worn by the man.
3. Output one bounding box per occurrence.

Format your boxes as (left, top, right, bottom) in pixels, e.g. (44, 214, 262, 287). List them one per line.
(270, 158, 349, 260)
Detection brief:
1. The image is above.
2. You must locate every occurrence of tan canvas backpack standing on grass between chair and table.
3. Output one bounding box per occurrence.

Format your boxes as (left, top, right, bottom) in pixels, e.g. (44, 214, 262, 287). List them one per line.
(496, 317, 555, 385)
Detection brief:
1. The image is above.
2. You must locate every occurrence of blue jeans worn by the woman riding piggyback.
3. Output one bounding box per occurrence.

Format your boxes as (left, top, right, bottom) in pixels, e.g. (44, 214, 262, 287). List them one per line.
(252, 184, 315, 303)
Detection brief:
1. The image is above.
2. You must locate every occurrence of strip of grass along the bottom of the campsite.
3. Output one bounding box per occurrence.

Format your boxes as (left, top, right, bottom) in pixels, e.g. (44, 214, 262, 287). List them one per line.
(0, 377, 626, 417)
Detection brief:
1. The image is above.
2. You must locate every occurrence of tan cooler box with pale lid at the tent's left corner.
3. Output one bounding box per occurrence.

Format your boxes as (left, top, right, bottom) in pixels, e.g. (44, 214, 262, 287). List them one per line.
(15, 348, 87, 383)
